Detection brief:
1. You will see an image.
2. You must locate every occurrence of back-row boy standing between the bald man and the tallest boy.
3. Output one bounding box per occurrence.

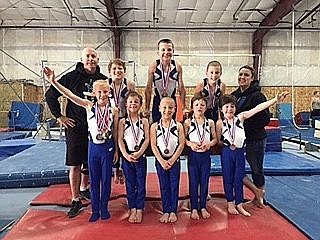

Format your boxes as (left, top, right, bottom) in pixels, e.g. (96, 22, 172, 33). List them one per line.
(108, 58, 135, 184)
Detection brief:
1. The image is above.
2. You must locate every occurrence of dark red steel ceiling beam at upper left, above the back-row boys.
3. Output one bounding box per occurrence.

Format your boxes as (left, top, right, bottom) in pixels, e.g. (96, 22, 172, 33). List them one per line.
(104, 0, 121, 58)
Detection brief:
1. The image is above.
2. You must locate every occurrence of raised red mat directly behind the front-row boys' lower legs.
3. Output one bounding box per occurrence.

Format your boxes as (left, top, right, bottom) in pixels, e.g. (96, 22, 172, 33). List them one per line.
(30, 173, 254, 207)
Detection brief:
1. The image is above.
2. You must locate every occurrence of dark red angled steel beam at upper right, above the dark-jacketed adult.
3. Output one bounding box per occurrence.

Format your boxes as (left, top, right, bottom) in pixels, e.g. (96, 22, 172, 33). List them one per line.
(252, 0, 301, 80)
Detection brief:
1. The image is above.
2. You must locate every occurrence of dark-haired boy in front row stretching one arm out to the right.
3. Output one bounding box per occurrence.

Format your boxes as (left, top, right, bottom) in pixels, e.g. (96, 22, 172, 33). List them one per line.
(219, 92, 288, 217)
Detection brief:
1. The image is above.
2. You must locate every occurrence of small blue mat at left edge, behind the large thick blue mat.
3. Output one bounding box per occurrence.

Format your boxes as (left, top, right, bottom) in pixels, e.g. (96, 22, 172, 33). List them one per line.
(0, 138, 36, 161)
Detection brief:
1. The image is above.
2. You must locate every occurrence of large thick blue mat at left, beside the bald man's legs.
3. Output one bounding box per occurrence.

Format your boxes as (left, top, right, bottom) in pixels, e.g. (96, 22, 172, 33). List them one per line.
(0, 141, 68, 188)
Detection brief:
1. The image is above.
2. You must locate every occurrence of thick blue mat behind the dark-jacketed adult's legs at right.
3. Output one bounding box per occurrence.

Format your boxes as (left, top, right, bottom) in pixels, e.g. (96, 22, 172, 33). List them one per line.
(210, 151, 320, 176)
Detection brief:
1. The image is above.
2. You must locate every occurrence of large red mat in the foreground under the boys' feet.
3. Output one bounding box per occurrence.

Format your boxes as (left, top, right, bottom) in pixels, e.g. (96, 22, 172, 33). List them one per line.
(4, 198, 307, 240)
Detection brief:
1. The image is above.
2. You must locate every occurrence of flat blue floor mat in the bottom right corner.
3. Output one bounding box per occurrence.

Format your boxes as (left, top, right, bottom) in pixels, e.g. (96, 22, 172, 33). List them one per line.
(266, 175, 320, 240)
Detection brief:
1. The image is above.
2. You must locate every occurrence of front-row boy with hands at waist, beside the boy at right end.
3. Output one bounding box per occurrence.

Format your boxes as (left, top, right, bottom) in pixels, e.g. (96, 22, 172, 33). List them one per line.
(184, 93, 218, 220)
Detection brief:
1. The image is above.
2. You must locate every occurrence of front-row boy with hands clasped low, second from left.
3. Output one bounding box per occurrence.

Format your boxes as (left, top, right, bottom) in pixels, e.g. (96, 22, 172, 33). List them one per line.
(118, 92, 149, 223)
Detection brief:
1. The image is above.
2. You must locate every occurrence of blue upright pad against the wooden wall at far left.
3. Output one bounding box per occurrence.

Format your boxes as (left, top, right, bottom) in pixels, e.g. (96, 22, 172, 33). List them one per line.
(9, 101, 43, 130)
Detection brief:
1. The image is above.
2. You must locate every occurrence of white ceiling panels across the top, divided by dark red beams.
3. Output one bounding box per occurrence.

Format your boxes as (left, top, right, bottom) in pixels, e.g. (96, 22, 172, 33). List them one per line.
(0, 0, 320, 30)
